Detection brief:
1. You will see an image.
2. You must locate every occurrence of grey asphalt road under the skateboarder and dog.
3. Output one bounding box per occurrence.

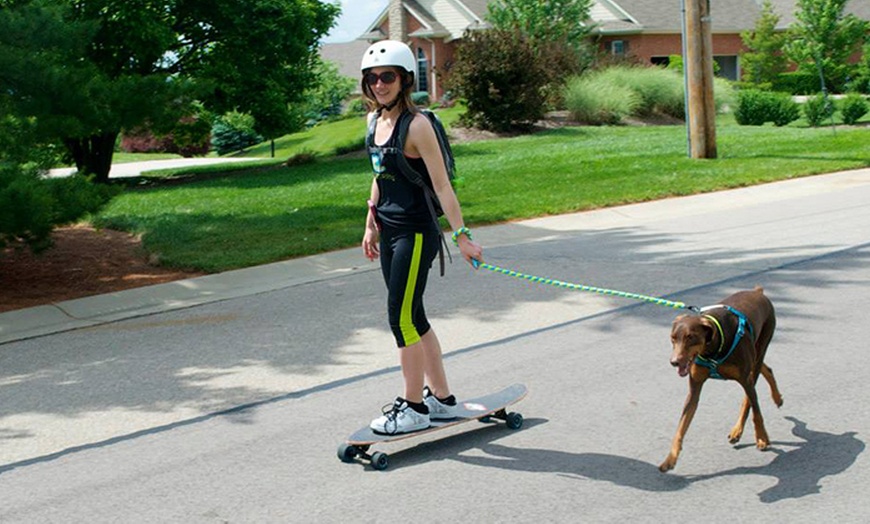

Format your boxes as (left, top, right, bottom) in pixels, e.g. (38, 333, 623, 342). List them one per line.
(0, 170, 870, 523)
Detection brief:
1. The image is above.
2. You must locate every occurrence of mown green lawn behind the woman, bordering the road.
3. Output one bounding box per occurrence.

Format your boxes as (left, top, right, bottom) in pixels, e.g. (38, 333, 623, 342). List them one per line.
(93, 112, 870, 272)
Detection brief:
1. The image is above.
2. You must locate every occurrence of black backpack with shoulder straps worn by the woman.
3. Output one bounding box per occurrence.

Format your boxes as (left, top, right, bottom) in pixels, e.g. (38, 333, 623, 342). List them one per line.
(366, 109, 457, 276)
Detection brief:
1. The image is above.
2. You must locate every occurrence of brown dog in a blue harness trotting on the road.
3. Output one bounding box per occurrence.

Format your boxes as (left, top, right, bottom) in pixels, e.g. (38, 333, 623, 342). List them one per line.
(659, 287, 782, 472)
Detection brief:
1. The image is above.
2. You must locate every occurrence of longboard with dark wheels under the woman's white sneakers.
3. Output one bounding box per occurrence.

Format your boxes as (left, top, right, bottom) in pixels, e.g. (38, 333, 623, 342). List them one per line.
(338, 384, 528, 470)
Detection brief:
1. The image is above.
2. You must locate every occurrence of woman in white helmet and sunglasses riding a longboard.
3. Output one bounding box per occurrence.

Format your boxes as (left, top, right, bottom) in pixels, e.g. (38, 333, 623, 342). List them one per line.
(360, 40, 483, 434)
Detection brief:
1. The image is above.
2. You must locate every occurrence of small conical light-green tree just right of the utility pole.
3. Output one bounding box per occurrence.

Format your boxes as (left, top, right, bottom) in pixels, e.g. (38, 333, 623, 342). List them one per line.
(740, 0, 786, 86)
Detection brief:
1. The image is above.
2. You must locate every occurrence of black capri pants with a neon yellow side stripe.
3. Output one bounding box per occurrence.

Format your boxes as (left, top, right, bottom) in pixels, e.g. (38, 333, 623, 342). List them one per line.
(380, 226, 441, 348)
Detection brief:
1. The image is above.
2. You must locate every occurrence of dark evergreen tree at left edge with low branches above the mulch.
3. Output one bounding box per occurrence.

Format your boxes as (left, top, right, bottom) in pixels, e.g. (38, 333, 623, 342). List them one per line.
(0, 4, 113, 251)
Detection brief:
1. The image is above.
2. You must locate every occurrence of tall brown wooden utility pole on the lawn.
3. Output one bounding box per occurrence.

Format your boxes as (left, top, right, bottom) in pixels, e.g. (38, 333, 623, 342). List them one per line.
(683, 0, 716, 158)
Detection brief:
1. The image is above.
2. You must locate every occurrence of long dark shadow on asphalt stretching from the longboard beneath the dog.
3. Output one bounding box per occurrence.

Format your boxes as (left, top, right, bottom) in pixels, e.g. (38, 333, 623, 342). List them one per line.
(452, 417, 865, 503)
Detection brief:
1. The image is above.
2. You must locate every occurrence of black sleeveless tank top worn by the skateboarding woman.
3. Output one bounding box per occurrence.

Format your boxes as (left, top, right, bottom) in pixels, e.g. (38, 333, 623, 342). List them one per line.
(369, 111, 436, 231)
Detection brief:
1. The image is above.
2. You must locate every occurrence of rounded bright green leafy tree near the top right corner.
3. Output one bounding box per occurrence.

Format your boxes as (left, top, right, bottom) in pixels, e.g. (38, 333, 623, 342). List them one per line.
(785, 0, 870, 89)
